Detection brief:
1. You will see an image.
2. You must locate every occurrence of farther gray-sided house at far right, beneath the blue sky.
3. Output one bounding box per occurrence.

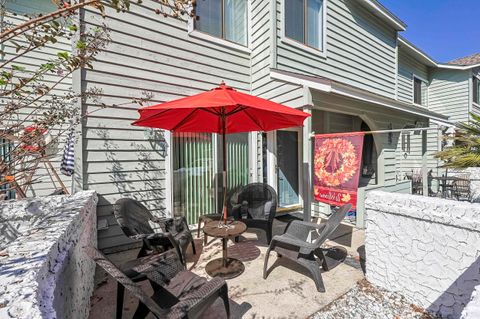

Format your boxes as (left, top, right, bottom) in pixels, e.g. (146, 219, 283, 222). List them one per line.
(397, 37, 480, 181)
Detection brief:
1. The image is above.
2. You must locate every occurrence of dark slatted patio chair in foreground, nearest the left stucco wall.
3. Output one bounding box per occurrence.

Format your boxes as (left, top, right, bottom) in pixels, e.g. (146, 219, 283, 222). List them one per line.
(85, 247, 230, 319)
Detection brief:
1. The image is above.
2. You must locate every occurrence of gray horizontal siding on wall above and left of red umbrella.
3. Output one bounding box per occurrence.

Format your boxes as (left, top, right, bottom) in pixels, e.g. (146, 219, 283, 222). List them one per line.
(82, 1, 250, 249)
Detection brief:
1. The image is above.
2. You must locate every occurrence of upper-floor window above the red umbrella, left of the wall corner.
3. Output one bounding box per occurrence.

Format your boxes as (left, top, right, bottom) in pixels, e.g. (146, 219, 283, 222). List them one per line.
(195, 0, 248, 46)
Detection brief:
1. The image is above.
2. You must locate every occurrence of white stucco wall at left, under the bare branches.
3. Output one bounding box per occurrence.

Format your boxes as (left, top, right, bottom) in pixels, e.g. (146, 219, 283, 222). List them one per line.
(0, 191, 97, 319)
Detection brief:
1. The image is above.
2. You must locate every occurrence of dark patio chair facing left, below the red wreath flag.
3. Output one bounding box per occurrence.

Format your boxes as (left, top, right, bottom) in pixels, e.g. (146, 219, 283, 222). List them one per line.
(263, 204, 352, 292)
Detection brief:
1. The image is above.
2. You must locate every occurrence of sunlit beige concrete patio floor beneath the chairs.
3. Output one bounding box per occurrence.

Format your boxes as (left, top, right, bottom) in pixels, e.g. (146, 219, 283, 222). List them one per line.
(90, 215, 364, 319)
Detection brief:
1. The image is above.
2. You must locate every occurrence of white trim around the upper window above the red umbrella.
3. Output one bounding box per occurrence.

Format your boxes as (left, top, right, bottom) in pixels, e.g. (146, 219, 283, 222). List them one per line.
(187, 0, 252, 54)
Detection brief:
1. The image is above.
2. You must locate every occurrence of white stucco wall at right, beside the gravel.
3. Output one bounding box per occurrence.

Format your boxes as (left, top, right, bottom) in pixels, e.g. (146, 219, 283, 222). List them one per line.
(365, 191, 480, 318)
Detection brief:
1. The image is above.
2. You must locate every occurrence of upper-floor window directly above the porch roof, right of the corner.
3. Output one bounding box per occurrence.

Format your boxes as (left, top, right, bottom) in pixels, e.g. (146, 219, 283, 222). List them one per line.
(284, 0, 325, 50)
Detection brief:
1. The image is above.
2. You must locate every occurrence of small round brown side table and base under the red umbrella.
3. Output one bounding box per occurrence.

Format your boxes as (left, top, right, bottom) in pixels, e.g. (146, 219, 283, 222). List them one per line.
(203, 221, 247, 279)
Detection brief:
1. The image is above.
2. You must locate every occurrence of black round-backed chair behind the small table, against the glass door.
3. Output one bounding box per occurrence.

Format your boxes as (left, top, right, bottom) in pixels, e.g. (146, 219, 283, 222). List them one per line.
(233, 183, 277, 244)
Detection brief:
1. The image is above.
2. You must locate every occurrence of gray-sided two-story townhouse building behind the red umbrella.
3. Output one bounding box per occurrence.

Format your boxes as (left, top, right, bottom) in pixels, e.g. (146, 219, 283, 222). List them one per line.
(0, 0, 478, 250)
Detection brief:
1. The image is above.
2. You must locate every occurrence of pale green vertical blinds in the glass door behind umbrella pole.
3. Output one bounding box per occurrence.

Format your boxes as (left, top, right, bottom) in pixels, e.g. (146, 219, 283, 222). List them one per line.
(173, 133, 249, 224)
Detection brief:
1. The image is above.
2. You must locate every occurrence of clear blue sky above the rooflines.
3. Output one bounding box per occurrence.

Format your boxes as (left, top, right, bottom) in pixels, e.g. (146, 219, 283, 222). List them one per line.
(379, 0, 480, 62)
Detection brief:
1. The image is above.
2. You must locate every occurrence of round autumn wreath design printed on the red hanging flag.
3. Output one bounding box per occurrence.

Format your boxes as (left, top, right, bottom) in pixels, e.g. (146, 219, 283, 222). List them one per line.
(314, 138, 359, 186)
